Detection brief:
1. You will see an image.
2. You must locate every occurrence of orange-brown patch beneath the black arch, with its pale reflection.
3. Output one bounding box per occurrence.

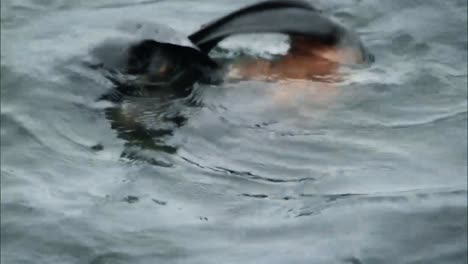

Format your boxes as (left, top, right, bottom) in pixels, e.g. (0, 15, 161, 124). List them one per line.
(230, 37, 348, 105)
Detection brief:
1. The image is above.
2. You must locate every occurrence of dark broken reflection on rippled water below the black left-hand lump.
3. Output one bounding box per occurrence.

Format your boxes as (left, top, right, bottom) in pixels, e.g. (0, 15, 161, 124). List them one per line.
(105, 95, 196, 166)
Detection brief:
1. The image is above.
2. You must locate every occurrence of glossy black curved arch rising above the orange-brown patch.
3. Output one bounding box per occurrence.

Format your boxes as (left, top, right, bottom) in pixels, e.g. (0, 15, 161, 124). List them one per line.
(189, 0, 345, 53)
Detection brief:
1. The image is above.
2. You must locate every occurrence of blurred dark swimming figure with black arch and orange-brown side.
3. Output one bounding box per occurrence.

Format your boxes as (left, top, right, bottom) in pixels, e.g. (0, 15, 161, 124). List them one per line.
(94, 0, 374, 96)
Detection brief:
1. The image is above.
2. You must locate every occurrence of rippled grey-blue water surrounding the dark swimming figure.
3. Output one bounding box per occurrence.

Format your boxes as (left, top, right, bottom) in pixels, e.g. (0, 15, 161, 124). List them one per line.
(1, 0, 467, 264)
